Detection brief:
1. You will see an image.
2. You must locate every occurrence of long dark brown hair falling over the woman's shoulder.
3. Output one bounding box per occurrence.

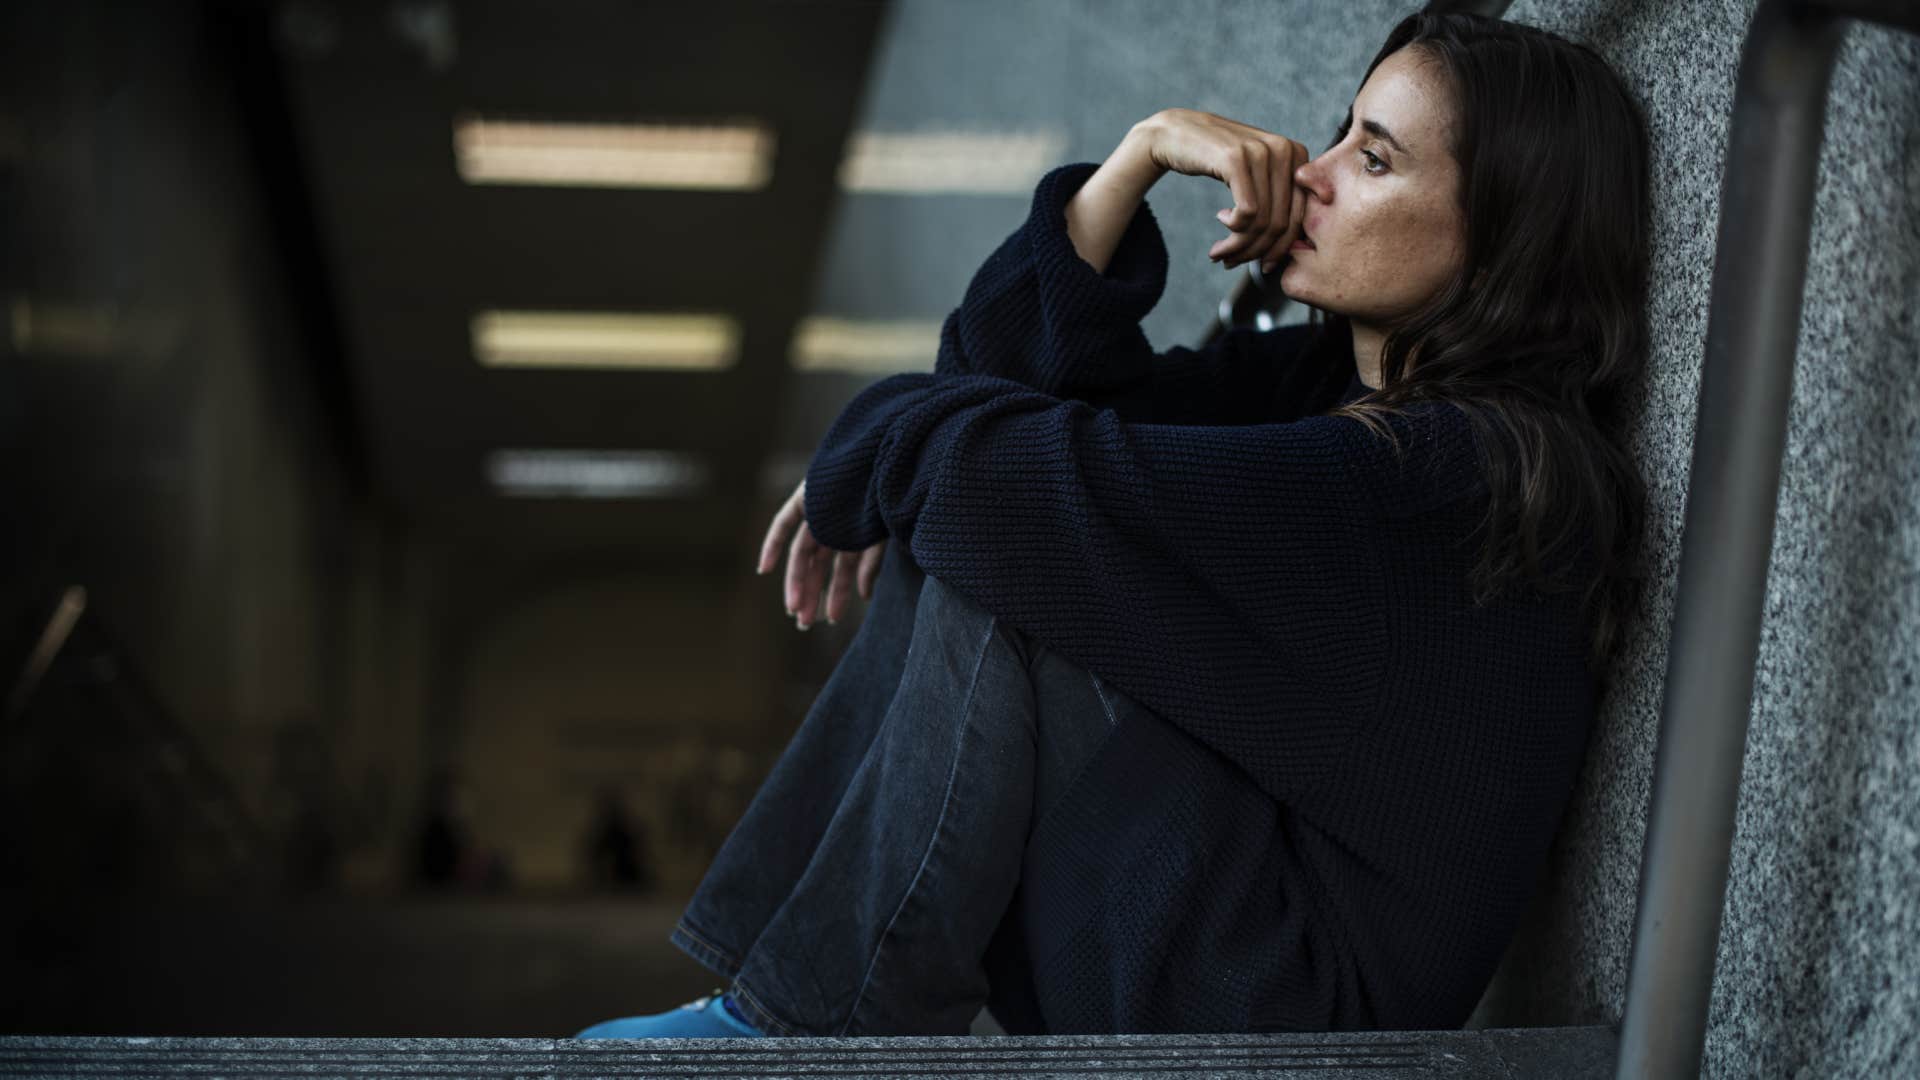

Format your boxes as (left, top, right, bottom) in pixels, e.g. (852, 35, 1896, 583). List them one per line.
(1309, 12, 1651, 682)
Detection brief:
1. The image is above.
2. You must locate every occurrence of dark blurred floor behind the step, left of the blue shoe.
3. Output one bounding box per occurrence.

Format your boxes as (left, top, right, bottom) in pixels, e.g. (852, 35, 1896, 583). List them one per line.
(0, 896, 724, 1038)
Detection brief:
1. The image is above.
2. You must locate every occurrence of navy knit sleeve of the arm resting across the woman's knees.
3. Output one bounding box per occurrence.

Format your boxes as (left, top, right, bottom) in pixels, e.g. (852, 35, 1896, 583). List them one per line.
(804, 375, 1386, 796)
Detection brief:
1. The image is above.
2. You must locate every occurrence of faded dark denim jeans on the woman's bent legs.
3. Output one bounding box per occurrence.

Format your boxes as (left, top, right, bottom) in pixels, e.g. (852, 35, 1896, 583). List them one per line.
(672, 542, 1139, 1036)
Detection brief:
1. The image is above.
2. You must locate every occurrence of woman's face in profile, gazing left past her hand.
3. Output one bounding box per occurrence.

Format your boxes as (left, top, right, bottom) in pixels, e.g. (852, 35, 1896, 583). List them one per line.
(1281, 48, 1465, 329)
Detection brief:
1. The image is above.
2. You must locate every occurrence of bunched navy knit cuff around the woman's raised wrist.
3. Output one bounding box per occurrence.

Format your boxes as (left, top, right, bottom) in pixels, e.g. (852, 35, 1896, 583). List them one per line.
(1025, 161, 1167, 327)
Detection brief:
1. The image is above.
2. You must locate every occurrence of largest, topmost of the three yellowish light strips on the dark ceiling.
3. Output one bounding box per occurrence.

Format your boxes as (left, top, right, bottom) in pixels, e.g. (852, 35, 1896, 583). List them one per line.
(453, 117, 774, 190)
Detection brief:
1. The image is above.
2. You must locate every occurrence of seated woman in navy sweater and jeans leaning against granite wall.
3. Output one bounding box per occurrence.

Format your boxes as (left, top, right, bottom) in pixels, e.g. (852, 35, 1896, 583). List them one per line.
(582, 13, 1647, 1038)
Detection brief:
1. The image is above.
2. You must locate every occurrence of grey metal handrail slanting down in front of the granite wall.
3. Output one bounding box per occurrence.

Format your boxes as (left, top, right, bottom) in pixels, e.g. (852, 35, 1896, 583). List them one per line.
(1617, 0, 1920, 1080)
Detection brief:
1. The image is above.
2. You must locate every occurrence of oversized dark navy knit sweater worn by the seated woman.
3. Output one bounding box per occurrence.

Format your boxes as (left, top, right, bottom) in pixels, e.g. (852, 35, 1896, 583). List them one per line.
(806, 163, 1594, 1034)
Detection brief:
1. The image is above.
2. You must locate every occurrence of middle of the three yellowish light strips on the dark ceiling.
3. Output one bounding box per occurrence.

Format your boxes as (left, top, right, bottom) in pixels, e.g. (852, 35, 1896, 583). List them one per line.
(470, 311, 739, 371)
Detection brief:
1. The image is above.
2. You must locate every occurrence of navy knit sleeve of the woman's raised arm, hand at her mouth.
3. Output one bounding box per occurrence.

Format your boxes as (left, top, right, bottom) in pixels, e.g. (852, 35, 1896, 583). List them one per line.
(933, 161, 1311, 423)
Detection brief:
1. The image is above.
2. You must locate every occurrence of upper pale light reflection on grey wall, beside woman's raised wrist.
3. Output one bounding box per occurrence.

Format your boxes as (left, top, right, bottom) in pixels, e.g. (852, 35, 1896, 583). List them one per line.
(839, 131, 1068, 194)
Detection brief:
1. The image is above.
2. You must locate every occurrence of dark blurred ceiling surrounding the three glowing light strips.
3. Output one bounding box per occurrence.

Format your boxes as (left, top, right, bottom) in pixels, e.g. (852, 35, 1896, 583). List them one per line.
(275, 0, 890, 563)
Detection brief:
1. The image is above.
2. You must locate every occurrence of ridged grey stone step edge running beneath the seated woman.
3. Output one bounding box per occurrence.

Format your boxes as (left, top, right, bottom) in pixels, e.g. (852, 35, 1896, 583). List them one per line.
(0, 1028, 1617, 1080)
